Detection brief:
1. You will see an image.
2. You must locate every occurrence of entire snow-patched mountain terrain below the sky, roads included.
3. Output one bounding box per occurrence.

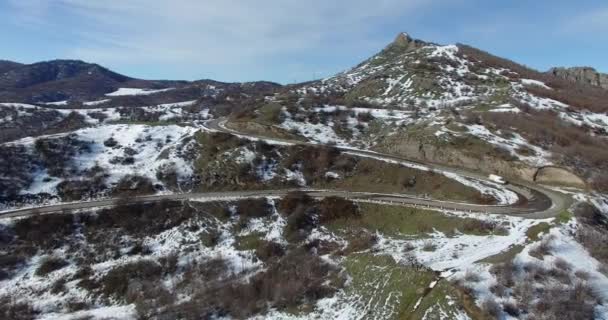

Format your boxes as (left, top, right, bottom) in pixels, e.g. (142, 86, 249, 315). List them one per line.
(0, 33, 608, 320)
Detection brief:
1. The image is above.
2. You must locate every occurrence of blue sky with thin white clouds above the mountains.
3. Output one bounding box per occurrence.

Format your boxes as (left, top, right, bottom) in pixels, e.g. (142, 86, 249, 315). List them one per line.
(0, 0, 608, 83)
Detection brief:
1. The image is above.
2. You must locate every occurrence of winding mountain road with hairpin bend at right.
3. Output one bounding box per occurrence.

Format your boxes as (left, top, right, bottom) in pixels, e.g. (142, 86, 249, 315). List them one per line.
(0, 118, 570, 219)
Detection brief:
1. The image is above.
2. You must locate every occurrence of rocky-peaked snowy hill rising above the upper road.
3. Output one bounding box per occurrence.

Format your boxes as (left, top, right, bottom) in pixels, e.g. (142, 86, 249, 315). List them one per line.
(230, 35, 608, 192)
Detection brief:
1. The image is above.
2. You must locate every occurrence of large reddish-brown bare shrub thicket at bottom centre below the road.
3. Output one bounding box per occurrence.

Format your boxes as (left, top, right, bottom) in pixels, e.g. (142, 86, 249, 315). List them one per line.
(164, 248, 340, 319)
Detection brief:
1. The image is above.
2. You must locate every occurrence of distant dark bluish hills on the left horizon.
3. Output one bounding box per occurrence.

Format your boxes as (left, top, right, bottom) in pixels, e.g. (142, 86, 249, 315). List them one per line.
(0, 60, 276, 106)
